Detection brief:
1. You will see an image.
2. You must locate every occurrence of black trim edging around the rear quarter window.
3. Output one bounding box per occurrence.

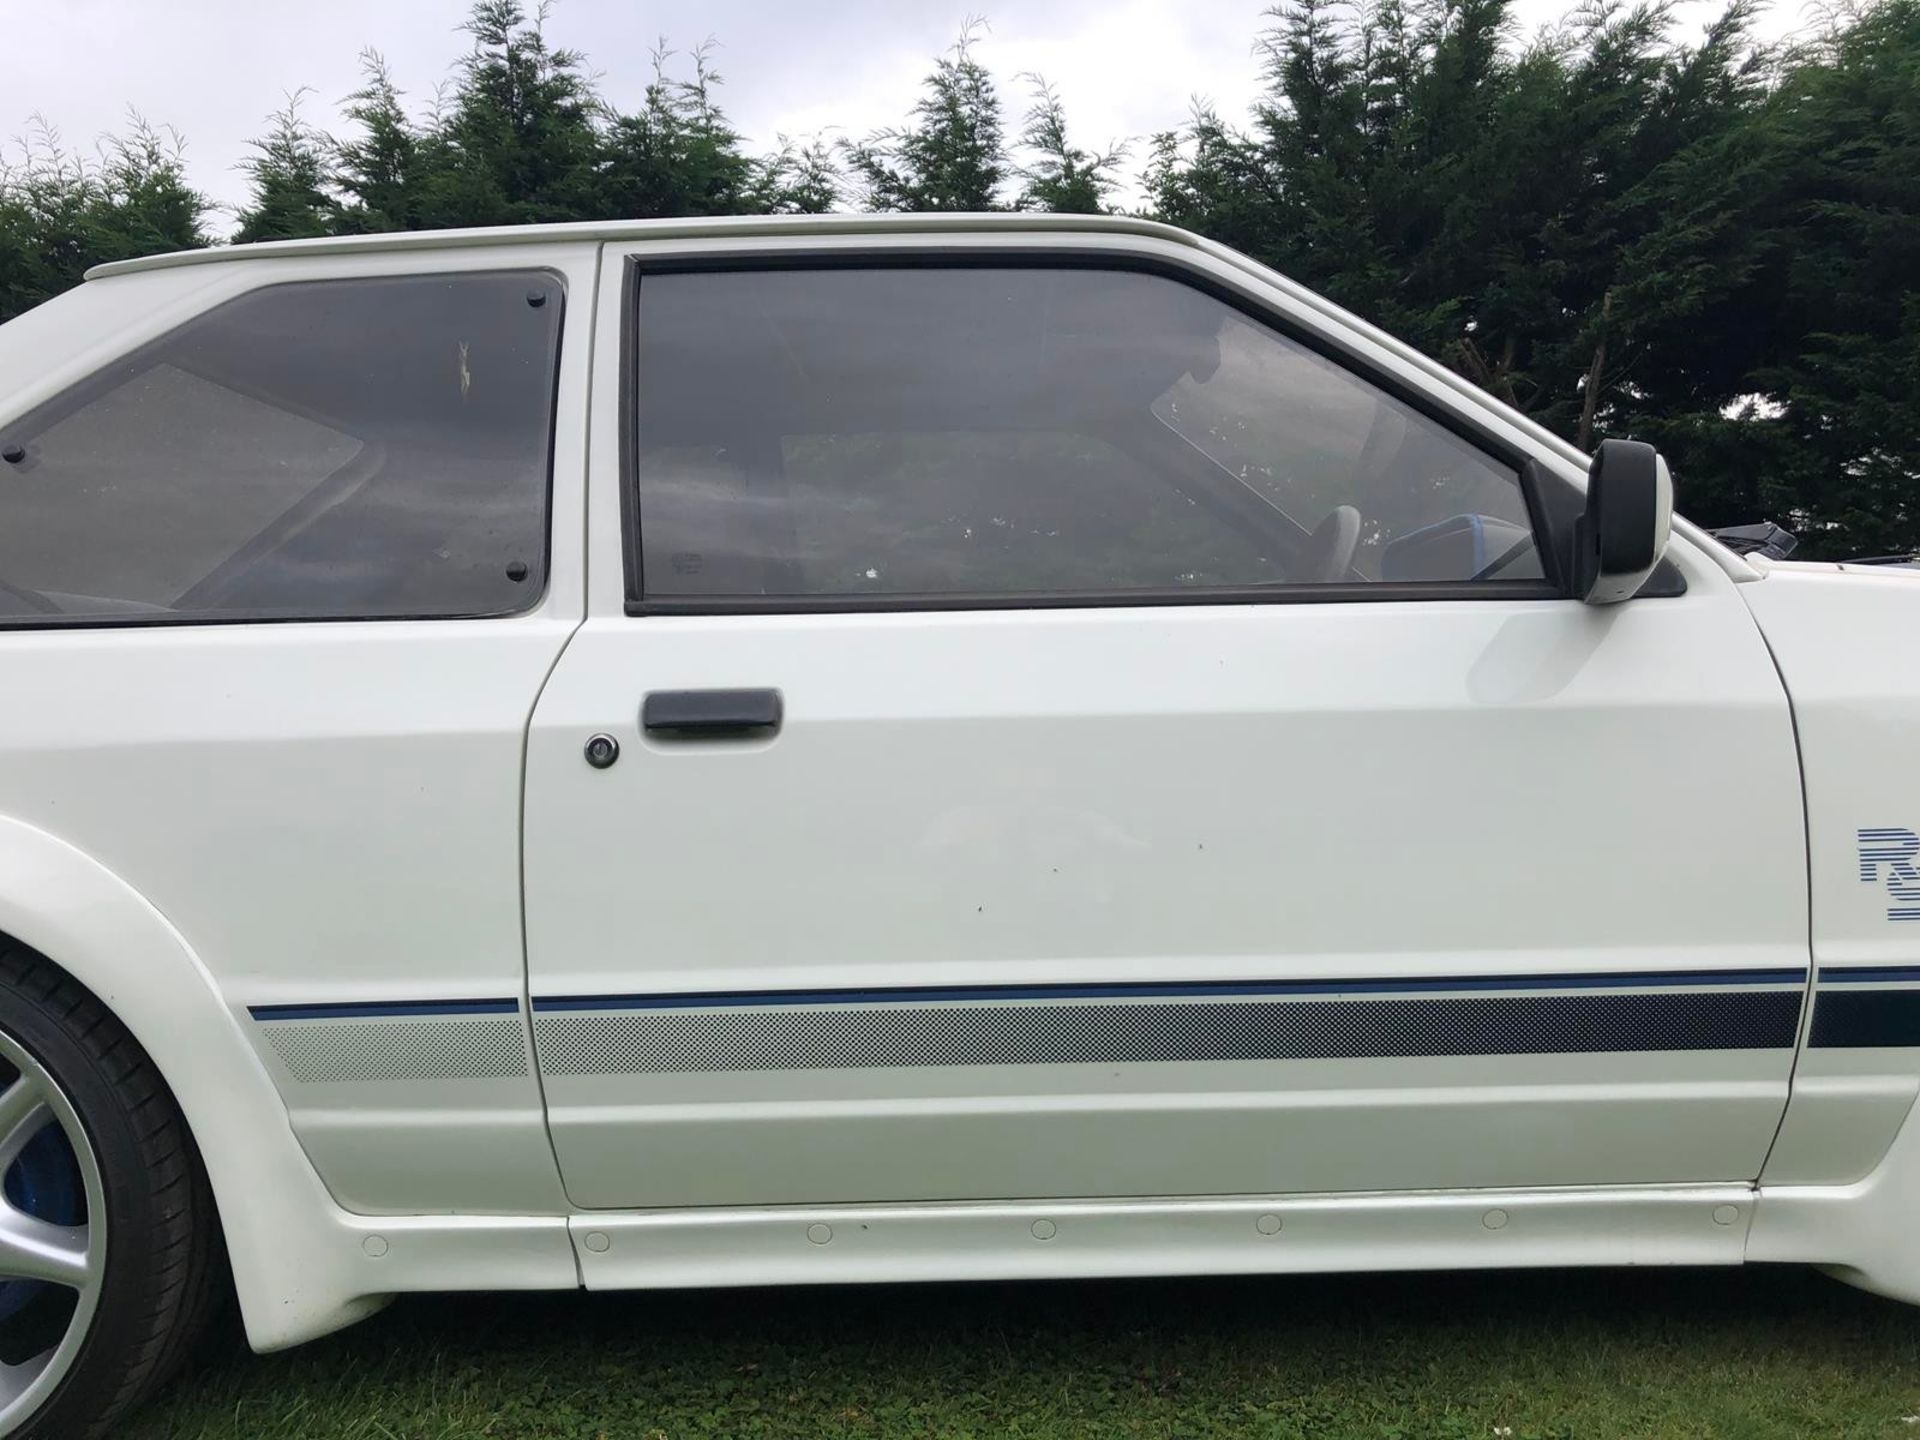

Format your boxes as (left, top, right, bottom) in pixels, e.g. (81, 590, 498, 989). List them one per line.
(0, 265, 568, 634)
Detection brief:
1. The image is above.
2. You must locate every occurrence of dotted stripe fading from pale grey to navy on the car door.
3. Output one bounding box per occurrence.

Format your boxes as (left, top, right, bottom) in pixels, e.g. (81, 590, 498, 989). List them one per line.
(534, 972, 1801, 1075)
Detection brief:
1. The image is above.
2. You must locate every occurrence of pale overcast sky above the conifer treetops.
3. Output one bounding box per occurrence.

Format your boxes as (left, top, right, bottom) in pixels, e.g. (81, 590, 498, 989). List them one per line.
(0, 0, 1803, 230)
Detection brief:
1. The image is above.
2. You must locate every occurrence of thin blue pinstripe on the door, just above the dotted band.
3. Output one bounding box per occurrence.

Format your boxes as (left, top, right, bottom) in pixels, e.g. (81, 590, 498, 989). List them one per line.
(534, 968, 1807, 1014)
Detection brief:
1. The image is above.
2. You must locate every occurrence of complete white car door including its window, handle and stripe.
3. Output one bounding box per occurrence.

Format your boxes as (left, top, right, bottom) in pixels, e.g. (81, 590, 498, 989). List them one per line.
(526, 236, 1807, 1208)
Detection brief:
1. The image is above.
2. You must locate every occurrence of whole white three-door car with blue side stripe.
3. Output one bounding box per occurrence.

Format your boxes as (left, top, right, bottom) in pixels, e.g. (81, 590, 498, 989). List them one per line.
(0, 215, 1920, 1434)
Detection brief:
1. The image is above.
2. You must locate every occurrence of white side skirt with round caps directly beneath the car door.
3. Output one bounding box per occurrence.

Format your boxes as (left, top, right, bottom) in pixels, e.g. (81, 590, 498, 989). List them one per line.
(568, 1185, 1755, 1290)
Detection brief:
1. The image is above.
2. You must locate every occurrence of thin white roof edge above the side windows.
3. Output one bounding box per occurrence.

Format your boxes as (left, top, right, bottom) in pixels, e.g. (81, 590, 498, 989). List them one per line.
(86, 211, 1202, 280)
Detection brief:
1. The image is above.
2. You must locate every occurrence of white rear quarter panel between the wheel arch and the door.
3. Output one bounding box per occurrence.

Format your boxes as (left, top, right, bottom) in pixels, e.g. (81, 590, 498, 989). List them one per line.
(0, 246, 597, 1236)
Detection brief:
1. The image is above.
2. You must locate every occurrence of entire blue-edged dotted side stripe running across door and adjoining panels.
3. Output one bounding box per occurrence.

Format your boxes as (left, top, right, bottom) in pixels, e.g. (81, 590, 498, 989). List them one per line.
(252, 966, 1920, 1083)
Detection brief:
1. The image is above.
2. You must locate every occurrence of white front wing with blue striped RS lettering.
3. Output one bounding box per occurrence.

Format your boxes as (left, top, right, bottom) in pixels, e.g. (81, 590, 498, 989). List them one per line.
(1743, 564, 1920, 1300)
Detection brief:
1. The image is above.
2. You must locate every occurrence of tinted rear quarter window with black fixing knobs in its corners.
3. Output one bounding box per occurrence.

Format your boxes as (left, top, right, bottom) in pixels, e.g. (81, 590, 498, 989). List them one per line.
(0, 273, 563, 622)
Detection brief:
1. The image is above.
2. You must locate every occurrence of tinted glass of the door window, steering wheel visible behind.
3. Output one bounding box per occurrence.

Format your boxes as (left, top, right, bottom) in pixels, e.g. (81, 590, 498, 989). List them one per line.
(636, 267, 1542, 603)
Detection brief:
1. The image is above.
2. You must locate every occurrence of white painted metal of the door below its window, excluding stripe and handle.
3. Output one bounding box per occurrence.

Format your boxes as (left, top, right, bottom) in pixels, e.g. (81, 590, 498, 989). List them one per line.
(528, 599, 1807, 1208)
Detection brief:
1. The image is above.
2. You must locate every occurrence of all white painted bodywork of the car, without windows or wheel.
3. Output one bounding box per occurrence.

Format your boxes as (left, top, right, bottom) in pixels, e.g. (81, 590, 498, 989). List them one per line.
(0, 217, 1920, 1348)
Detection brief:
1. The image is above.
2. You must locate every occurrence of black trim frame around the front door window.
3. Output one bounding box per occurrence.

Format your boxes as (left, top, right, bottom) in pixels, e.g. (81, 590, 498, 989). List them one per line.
(620, 242, 1686, 616)
